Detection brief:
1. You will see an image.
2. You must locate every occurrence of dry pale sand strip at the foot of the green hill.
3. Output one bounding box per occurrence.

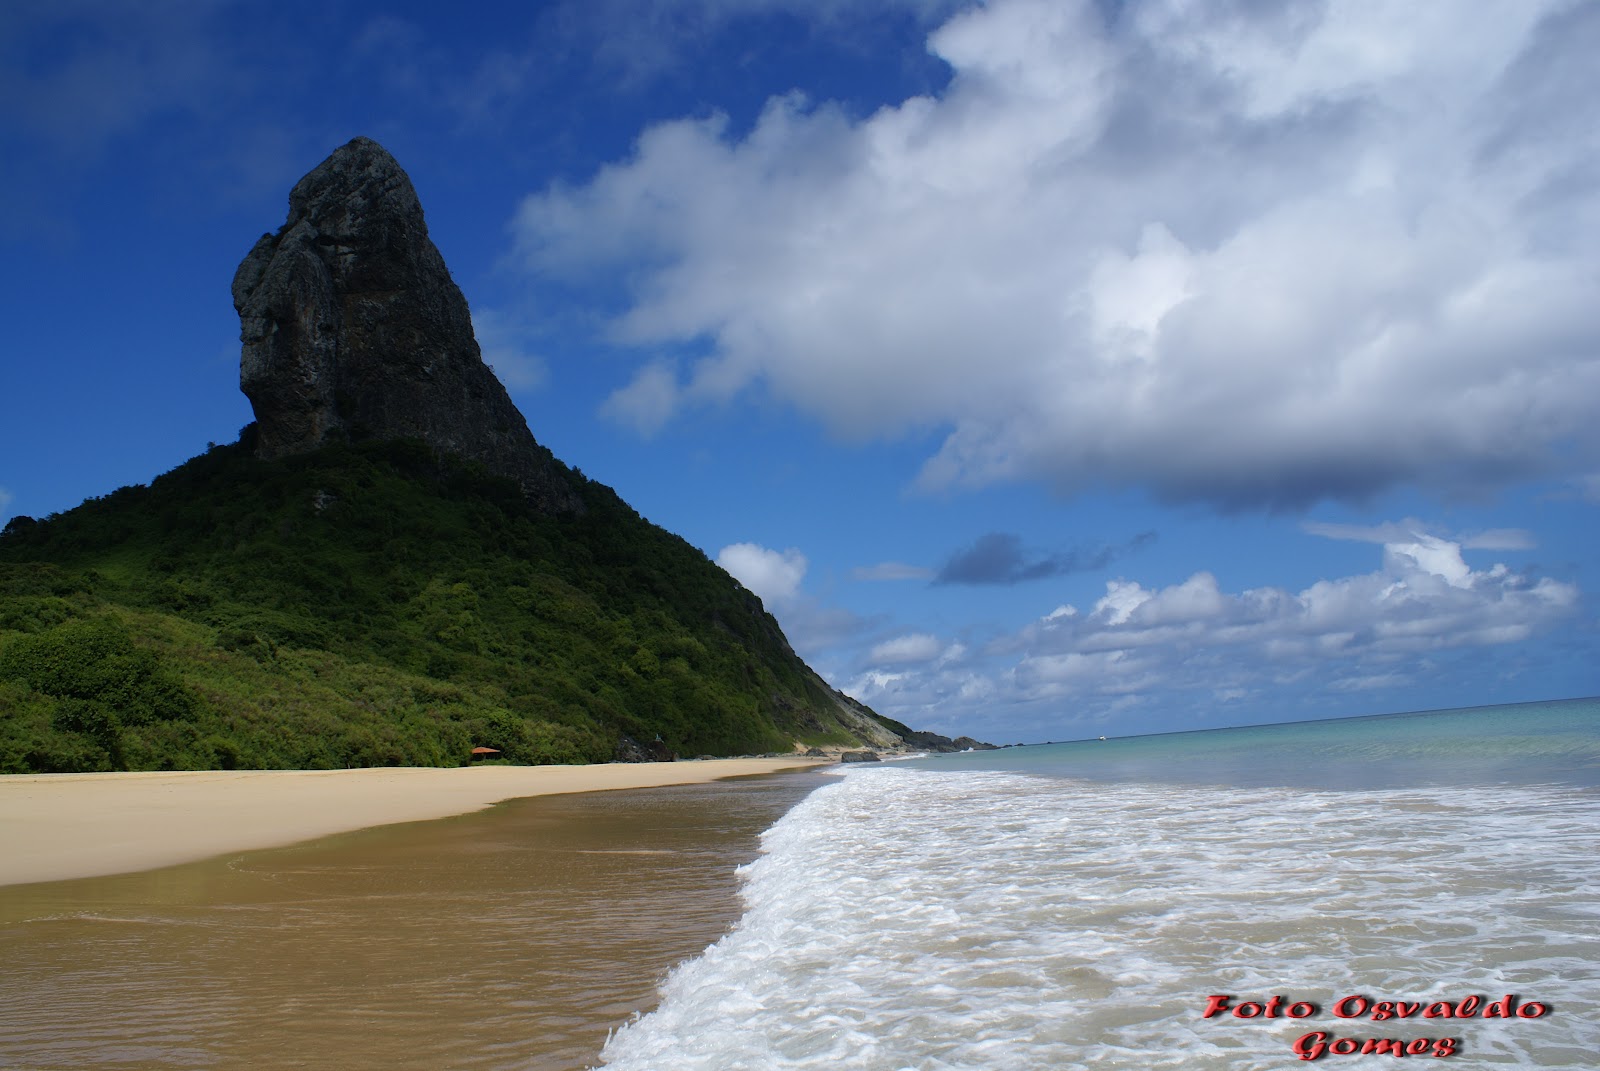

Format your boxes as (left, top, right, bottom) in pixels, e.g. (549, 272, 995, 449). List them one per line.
(0, 756, 826, 885)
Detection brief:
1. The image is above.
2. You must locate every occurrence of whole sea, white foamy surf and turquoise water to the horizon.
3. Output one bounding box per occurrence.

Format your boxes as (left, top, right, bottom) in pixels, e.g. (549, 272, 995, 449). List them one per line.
(598, 700, 1600, 1071)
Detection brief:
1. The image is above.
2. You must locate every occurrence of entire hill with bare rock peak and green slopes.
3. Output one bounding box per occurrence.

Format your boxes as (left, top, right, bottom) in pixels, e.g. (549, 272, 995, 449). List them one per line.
(0, 138, 966, 772)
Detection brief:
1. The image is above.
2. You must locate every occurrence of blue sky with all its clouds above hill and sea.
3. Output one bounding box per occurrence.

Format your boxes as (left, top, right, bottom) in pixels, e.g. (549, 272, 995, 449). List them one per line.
(0, 0, 1600, 743)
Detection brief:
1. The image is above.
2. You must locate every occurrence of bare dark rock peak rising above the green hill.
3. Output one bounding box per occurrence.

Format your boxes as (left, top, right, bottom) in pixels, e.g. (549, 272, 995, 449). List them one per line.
(234, 138, 582, 512)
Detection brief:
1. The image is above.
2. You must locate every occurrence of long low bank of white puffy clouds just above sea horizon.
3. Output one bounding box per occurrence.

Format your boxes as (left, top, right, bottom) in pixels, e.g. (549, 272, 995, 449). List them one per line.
(850, 523, 1579, 717)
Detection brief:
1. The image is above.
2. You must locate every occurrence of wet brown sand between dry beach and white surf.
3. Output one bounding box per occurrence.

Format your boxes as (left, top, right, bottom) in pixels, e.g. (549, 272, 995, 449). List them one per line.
(0, 762, 827, 1071)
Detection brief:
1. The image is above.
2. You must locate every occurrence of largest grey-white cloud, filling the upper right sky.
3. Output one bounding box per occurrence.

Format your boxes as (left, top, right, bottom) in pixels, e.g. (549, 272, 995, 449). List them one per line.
(515, 0, 1600, 507)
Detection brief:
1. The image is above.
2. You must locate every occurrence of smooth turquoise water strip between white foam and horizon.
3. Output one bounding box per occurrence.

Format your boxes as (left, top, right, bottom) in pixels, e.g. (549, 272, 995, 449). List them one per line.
(909, 698, 1600, 789)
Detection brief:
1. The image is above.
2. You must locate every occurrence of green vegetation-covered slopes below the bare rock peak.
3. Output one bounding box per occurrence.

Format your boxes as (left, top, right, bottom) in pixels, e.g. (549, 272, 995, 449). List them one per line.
(0, 427, 904, 773)
